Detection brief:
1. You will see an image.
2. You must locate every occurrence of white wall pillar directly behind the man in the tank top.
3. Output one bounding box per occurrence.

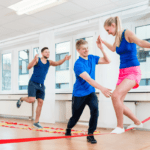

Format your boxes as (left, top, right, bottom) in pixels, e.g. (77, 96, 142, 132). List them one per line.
(39, 31, 55, 123)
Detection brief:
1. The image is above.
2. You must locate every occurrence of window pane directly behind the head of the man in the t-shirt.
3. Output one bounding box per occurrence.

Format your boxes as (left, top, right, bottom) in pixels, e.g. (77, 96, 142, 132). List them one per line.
(75, 37, 94, 60)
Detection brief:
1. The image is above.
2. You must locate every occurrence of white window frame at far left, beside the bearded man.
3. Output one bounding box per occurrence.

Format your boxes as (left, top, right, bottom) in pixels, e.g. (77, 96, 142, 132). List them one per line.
(0, 43, 39, 94)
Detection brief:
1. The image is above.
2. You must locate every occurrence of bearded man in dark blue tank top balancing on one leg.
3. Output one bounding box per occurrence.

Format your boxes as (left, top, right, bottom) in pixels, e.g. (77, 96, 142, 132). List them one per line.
(17, 47, 71, 128)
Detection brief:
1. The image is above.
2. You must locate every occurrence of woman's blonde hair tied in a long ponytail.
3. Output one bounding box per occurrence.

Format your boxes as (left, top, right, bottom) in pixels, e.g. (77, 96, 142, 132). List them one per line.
(104, 16, 123, 47)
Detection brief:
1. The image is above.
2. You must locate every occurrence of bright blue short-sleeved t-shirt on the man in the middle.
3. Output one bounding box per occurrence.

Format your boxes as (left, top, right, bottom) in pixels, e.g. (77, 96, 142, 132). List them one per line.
(73, 55, 100, 97)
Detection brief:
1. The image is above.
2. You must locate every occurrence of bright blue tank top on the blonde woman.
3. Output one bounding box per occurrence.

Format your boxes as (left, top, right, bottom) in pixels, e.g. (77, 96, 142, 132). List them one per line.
(116, 30, 140, 69)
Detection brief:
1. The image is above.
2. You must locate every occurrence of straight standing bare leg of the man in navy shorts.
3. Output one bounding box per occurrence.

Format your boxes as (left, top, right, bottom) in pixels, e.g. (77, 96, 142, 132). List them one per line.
(35, 98, 43, 123)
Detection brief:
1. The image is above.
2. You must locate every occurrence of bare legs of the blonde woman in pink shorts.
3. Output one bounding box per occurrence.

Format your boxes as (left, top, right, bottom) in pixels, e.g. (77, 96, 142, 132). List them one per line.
(112, 79, 136, 128)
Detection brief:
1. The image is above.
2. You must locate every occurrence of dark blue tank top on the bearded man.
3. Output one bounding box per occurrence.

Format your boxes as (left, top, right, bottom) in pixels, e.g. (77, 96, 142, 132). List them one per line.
(30, 58, 50, 84)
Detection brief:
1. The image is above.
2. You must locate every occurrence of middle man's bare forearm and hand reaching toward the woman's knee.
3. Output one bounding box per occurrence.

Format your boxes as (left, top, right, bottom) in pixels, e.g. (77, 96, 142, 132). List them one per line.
(79, 72, 111, 97)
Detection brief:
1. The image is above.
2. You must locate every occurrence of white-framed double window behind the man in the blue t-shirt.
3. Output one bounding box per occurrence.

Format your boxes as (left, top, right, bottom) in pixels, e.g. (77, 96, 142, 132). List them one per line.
(55, 31, 96, 93)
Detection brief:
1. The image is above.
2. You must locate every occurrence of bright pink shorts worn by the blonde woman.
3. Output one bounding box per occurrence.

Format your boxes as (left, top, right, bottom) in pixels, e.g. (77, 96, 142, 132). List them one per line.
(117, 66, 142, 89)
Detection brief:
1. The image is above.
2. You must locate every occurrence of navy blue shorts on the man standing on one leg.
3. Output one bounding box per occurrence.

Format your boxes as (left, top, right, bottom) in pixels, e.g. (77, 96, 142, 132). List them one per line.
(28, 80, 45, 100)
